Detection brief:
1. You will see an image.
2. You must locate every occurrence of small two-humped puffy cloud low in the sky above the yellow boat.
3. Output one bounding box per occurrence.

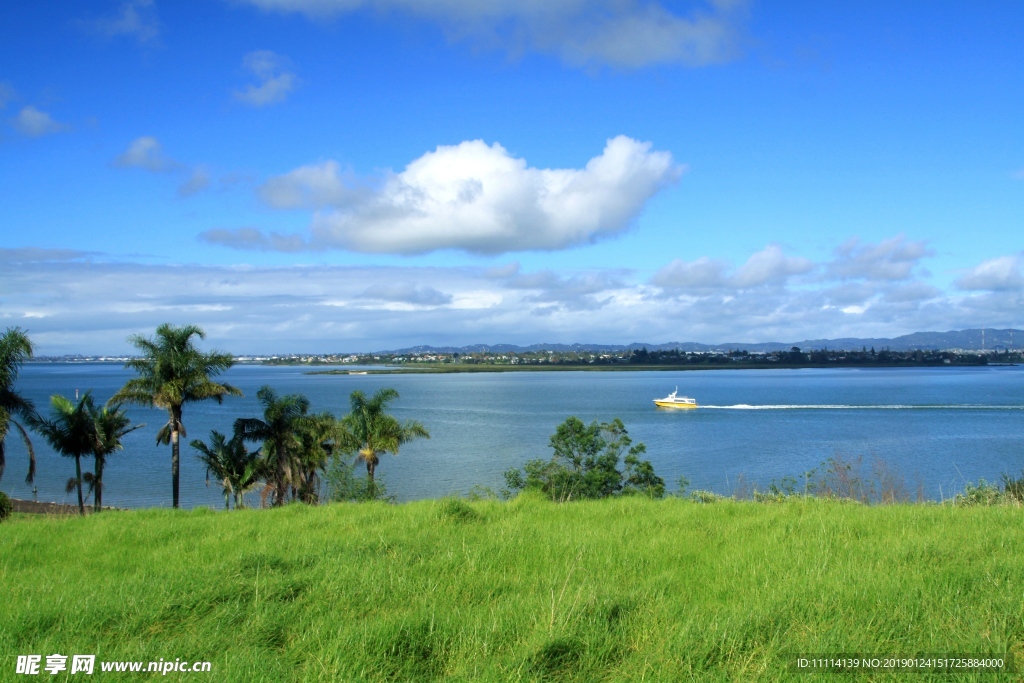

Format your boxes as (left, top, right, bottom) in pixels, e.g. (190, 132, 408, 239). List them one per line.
(651, 244, 814, 292)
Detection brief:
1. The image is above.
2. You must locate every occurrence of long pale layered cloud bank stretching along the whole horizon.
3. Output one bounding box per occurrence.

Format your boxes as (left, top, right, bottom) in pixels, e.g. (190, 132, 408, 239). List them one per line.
(0, 240, 1024, 353)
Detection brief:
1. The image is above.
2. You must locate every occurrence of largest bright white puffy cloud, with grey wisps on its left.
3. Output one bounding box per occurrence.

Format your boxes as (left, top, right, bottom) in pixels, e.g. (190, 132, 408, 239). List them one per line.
(203, 135, 683, 254)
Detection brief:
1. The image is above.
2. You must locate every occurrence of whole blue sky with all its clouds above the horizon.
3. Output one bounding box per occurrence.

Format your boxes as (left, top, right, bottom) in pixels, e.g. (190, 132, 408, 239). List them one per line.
(0, 0, 1024, 355)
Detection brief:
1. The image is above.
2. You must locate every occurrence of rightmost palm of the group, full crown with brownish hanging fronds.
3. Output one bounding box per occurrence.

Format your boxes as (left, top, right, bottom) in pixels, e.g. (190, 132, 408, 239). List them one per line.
(340, 388, 430, 484)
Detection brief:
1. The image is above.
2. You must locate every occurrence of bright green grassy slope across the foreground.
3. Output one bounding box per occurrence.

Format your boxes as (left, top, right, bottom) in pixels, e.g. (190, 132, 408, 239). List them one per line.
(0, 498, 1024, 681)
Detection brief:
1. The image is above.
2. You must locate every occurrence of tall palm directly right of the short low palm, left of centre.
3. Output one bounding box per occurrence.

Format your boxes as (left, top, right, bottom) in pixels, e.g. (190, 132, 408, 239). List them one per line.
(234, 386, 309, 506)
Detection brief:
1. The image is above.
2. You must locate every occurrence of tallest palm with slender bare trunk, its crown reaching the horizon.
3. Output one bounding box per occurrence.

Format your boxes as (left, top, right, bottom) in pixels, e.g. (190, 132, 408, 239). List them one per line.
(111, 323, 242, 508)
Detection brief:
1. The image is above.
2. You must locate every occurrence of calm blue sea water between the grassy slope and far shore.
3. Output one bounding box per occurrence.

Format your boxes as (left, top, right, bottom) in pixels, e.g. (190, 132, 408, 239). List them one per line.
(0, 364, 1024, 507)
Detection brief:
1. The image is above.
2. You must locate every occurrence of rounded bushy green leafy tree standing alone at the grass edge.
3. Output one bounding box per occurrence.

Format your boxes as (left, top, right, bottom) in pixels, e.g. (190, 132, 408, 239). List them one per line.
(505, 417, 665, 502)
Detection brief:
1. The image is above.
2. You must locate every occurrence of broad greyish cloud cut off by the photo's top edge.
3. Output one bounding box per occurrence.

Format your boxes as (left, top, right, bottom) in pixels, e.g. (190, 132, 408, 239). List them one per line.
(234, 0, 748, 68)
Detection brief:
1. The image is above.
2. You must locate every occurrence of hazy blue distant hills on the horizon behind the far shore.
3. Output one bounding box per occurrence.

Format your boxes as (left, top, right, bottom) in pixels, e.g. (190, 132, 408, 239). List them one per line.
(381, 328, 1024, 354)
